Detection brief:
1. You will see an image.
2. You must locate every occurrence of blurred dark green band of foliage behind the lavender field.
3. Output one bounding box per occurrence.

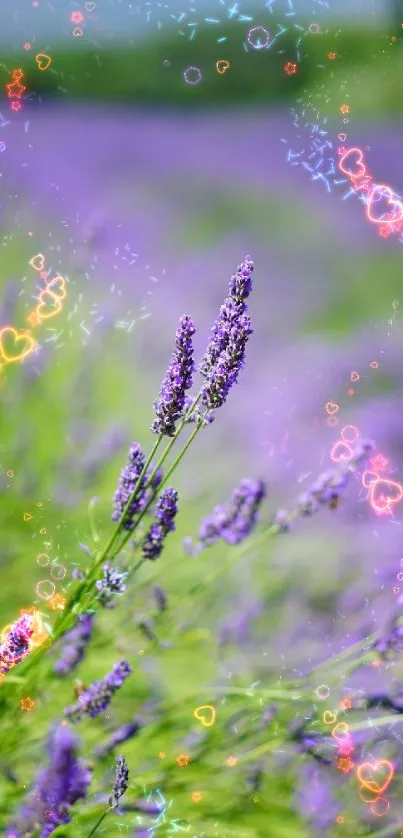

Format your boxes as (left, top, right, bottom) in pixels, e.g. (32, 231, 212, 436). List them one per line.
(0, 24, 401, 106)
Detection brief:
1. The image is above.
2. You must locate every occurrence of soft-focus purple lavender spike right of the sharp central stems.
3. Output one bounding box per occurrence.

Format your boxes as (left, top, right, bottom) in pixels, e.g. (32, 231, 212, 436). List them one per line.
(194, 478, 266, 553)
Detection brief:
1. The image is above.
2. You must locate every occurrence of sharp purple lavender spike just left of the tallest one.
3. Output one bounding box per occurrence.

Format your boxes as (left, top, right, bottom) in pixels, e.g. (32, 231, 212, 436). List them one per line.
(151, 315, 195, 436)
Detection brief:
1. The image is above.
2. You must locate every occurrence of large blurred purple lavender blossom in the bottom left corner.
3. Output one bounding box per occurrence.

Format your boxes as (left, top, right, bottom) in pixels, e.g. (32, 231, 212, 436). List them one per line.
(6, 722, 91, 838)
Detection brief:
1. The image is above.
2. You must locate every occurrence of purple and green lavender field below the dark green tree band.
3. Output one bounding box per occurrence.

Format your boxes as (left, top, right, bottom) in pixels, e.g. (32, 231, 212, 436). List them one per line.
(0, 104, 403, 838)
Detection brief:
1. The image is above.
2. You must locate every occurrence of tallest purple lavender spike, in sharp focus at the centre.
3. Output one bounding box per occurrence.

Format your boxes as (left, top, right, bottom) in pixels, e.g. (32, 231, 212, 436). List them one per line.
(199, 256, 253, 410)
